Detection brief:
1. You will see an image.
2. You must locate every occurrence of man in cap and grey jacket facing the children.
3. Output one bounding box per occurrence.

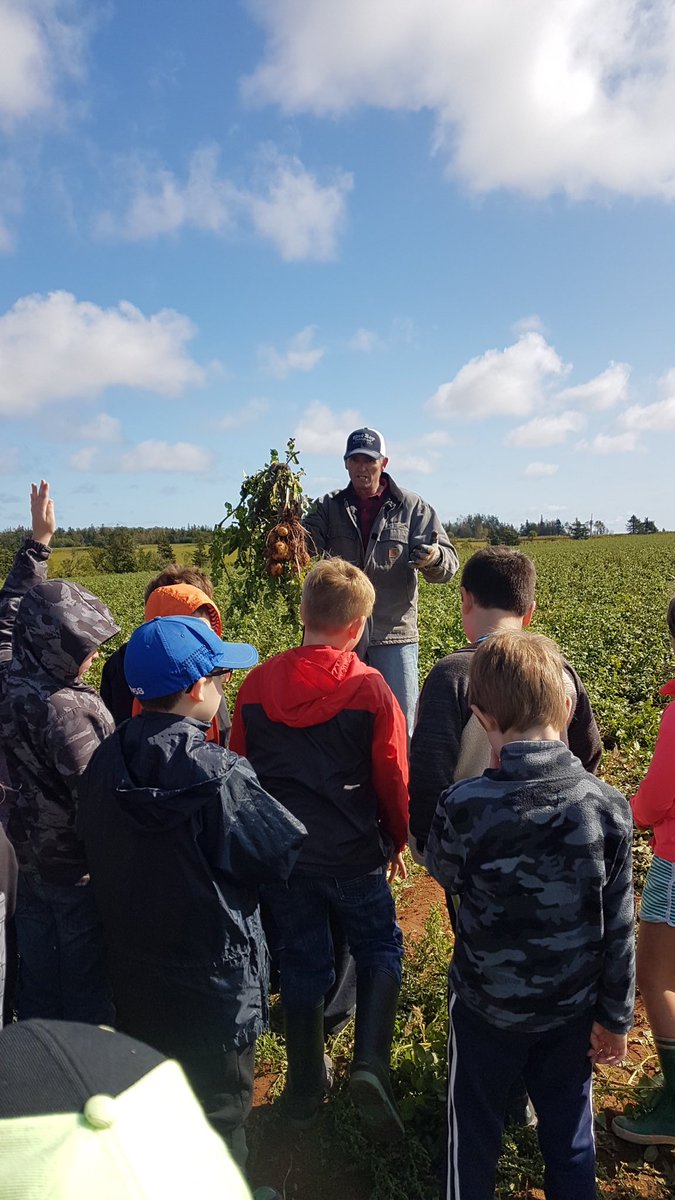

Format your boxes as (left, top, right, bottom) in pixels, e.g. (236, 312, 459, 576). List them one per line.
(304, 427, 459, 737)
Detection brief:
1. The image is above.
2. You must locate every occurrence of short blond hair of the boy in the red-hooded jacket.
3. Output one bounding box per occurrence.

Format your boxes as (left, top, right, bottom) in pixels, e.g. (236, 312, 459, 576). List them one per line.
(301, 558, 375, 634)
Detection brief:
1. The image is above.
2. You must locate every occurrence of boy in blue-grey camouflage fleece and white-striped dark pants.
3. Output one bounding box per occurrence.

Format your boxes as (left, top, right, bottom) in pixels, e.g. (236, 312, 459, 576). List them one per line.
(426, 630, 634, 1200)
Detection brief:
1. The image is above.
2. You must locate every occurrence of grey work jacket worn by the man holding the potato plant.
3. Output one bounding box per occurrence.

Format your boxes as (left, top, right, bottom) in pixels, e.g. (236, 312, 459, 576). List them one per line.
(303, 474, 459, 646)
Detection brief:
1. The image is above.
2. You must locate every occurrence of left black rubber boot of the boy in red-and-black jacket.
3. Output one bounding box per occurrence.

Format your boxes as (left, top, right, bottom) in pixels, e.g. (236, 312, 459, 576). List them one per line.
(281, 1002, 333, 1129)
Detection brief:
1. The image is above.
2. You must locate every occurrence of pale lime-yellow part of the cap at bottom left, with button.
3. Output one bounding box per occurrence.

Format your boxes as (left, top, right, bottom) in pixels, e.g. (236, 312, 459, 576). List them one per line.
(0, 1061, 250, 1200)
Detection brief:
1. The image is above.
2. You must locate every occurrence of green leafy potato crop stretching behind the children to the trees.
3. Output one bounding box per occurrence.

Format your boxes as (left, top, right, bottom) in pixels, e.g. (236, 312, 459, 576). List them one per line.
(82, 534, 675, 791)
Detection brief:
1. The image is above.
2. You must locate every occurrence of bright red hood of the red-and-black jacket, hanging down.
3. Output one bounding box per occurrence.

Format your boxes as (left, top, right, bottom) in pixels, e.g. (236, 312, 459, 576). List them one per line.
(249, 646, 365, 728)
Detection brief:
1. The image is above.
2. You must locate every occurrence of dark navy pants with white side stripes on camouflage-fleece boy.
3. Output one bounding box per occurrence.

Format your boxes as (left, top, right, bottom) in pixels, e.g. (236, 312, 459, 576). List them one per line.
(446, 995, 596, 1200)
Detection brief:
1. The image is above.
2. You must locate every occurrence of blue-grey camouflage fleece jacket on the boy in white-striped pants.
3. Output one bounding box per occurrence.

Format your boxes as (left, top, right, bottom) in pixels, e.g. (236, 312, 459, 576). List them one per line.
(425, 742, 635, 1033)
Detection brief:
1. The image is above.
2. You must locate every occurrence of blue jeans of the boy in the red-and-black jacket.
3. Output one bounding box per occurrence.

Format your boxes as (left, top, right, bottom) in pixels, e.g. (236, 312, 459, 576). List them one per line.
(261, 868, 404, 1008)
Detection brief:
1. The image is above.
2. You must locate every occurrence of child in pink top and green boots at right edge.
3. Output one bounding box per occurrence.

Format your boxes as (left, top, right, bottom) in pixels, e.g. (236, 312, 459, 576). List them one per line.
(611, 598, 675, 1146)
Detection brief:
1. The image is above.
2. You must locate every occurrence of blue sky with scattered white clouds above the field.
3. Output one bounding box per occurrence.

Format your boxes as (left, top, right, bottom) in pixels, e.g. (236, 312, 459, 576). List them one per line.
(0, 0, 675, 530)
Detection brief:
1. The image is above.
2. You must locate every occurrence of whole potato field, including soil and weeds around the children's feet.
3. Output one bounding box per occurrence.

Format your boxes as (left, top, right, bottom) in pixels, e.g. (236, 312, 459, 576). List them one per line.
(64, 534, 675, 1200)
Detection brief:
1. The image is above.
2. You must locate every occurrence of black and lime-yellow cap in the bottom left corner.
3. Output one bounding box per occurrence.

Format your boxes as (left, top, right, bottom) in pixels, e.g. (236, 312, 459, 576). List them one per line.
(0, 1020, 250, 1200)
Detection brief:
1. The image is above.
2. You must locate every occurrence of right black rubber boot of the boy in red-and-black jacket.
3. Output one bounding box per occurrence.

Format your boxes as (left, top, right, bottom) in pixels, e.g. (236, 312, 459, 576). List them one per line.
(350, 971, 405, 1142)
